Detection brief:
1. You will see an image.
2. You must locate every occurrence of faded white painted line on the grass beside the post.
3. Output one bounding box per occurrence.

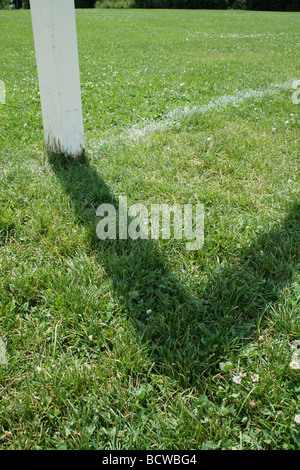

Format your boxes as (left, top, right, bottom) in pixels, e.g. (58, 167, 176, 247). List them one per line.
(90, 80, 294, 149)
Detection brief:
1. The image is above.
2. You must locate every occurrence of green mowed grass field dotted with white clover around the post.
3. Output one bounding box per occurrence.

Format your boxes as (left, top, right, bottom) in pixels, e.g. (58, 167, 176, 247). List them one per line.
(0, 10, 300, 450)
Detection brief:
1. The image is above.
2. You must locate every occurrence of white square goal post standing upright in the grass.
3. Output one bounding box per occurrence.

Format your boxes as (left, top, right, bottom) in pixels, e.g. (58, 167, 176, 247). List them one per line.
(30, 0, 85, 157)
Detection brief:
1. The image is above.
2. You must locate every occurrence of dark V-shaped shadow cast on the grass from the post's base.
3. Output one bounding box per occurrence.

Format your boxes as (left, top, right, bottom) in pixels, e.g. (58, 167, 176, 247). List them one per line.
(50, 154, 300, 386)
